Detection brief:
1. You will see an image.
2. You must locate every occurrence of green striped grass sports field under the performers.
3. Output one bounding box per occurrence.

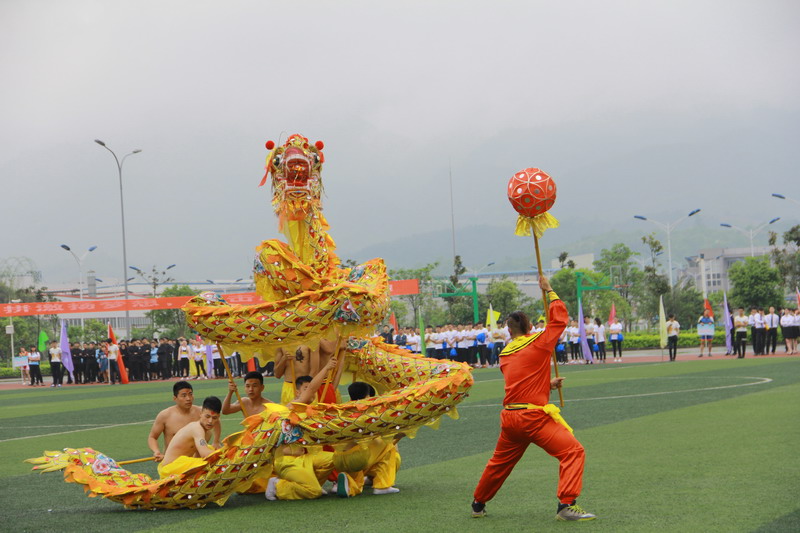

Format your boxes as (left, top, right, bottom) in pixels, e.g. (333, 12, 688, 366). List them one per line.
(0, 358, 800, 533)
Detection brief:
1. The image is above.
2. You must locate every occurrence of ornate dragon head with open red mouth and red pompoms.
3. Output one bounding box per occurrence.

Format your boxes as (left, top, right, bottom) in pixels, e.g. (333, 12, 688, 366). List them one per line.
(260, 134, 325, 220)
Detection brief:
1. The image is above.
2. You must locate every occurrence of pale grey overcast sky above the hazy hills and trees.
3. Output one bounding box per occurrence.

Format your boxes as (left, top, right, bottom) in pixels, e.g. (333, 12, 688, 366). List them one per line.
(0, 0, 800, 285)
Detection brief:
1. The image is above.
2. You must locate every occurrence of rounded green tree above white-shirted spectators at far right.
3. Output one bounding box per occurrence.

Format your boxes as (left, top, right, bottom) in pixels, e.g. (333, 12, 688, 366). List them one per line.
(728, 256, 783, 309)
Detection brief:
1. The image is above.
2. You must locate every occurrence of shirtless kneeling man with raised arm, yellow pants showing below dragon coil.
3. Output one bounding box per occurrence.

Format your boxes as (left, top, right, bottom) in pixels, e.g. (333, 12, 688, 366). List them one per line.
(264, 358, 336, 500)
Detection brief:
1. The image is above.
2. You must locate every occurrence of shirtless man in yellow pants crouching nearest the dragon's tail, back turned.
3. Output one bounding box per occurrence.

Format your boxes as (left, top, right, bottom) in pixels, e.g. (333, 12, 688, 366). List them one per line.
(158, 396, 222, 478)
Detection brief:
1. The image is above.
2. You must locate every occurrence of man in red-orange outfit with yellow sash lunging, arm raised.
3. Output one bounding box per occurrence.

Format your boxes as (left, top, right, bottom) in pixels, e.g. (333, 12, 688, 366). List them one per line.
(472, 276, 595, 520)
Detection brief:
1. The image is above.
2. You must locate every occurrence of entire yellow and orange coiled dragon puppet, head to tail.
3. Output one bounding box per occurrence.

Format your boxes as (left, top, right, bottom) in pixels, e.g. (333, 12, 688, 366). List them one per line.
(28, 135, 473, 509)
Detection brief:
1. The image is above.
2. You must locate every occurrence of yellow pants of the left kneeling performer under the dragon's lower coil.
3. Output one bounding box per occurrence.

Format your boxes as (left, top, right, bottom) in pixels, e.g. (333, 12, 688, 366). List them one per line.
(274, 452, 333, 500)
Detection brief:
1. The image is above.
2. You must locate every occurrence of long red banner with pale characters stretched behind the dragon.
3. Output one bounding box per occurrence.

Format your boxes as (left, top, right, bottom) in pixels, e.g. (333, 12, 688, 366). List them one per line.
(0, 279, 419, 317)
